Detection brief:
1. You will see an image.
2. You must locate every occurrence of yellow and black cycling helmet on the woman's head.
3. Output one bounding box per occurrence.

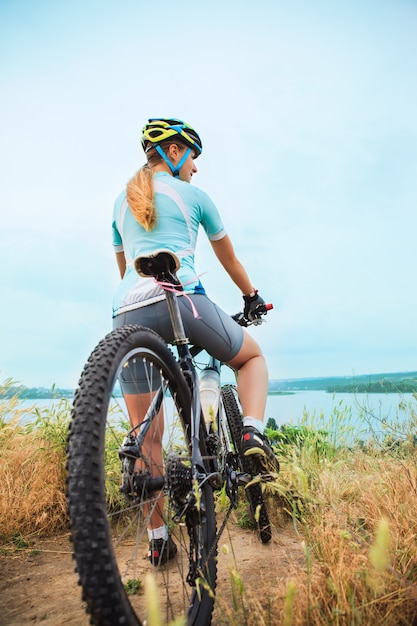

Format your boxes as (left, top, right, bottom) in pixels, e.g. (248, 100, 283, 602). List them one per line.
(141, 117, 203, 159)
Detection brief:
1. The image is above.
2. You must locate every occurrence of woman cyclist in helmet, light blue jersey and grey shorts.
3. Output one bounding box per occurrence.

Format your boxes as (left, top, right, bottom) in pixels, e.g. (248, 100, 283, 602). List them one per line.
(113, 118, 275, 564)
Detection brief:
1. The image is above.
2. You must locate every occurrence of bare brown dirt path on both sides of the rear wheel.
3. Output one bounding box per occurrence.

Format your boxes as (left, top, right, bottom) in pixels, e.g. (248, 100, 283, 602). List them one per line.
(0, 522, 305, 626)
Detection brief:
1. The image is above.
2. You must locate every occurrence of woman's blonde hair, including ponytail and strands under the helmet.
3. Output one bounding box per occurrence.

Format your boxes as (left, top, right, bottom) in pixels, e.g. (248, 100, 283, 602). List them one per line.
(126, 139, 183, 231)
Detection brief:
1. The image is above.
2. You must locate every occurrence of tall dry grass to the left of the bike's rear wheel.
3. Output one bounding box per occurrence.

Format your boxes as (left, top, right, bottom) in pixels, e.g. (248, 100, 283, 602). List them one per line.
(0, 380, 70, 541)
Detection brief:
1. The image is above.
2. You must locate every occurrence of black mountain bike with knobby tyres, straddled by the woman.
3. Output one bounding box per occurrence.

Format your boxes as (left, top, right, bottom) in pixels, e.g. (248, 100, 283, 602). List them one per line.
(67, 251, 279, 626)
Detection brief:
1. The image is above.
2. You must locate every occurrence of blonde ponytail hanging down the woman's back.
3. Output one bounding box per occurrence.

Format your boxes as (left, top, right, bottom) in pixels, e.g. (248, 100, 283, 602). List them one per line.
(126, 164, 156, 231)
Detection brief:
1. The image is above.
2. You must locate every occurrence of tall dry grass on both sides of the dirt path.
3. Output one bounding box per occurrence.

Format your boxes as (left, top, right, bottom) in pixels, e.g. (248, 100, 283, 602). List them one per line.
(0, 381, 417, 626)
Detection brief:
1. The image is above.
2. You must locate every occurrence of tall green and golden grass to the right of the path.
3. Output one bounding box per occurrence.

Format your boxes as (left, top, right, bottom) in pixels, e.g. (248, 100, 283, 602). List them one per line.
(266, 397, 417, 626)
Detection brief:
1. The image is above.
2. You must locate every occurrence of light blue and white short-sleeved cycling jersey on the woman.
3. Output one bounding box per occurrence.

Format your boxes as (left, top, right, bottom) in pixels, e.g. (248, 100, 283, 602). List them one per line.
(113, 172, 226, 317)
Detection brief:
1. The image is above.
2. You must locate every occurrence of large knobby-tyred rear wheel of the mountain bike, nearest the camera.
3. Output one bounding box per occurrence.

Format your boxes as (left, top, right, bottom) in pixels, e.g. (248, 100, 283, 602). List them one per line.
(67, 325, 217, 626)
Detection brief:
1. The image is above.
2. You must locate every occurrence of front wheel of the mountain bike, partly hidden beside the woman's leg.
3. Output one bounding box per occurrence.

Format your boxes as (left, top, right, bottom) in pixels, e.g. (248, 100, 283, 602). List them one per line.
(222, 385, 272, 543)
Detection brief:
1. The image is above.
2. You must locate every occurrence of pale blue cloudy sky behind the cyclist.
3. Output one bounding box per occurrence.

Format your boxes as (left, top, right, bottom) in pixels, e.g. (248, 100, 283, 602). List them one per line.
(0, 0, 417, 387)
